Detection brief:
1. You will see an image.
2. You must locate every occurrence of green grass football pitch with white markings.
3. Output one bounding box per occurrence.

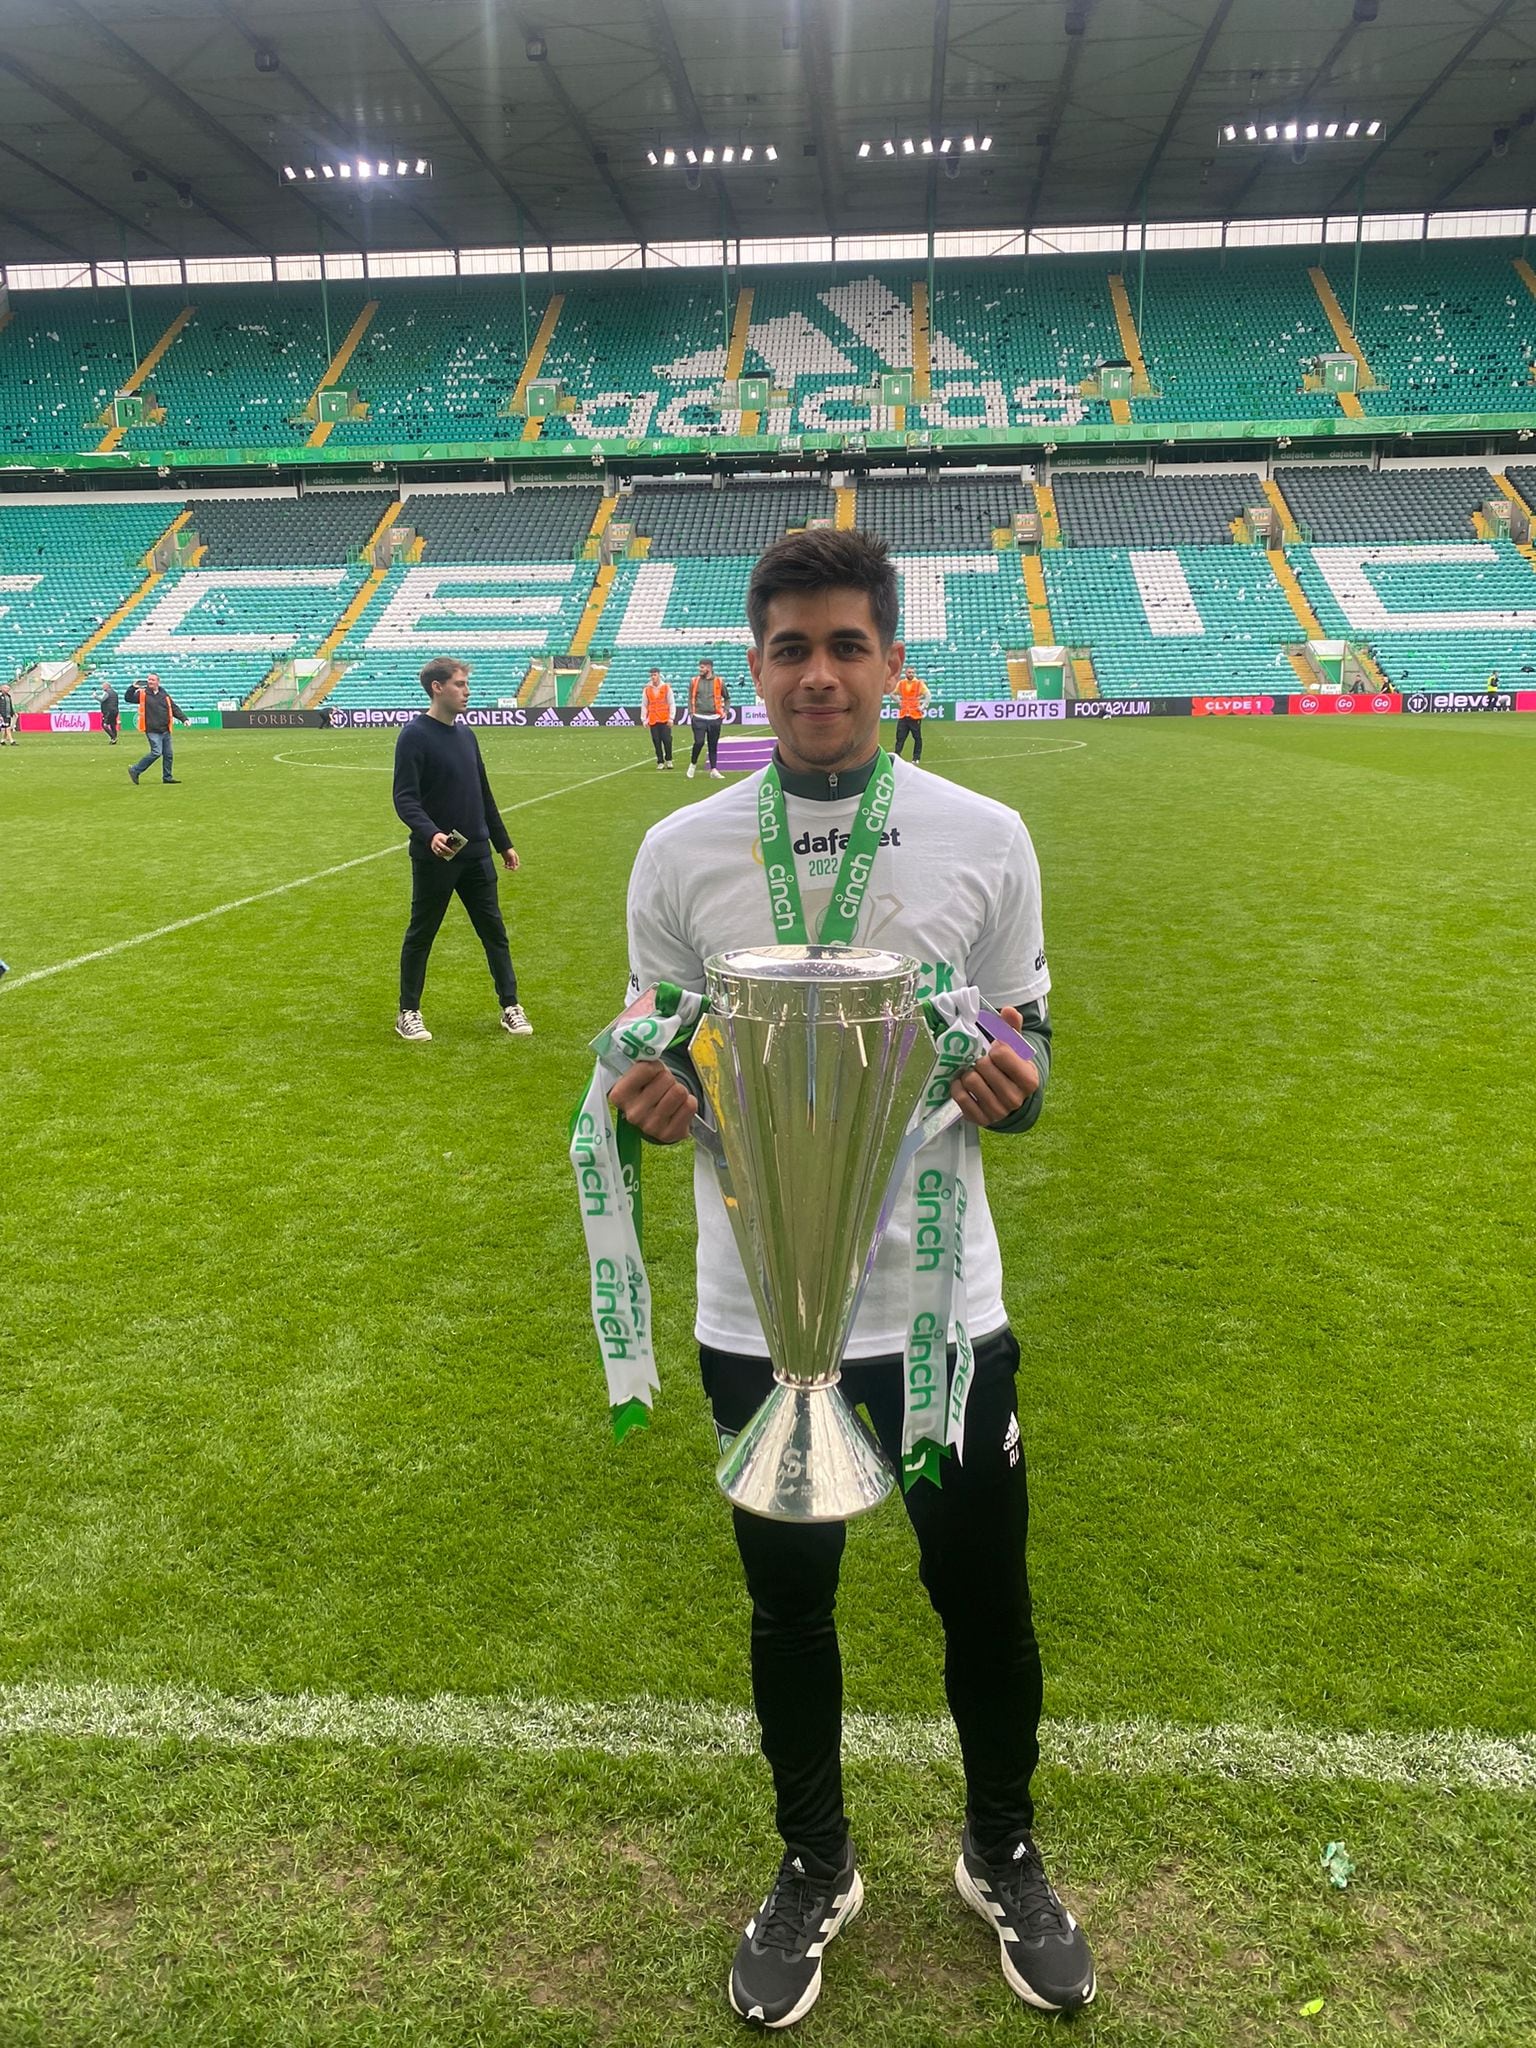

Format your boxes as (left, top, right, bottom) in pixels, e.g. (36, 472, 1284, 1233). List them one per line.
(0, 717, 1536, 2048)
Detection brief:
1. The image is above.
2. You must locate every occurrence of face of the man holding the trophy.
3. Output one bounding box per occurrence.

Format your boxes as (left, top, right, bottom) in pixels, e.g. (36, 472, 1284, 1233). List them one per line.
(748, 590, 905, 774)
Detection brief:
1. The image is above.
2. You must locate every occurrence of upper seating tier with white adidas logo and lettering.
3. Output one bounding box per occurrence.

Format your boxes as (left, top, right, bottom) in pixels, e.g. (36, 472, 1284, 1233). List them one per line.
(0, 242, 1536, 467)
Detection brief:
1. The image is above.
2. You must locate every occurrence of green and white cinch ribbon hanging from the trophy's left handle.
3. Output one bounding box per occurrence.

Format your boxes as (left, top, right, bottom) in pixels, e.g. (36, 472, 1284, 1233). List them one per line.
(571, 981, 705, 1440)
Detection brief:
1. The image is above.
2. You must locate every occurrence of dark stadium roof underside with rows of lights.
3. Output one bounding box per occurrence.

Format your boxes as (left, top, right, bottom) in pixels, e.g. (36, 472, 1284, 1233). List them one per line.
(0, 0, 1536, 262)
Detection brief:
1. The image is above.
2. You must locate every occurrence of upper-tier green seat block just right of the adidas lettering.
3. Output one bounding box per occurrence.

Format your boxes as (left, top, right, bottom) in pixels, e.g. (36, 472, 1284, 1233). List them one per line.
(1126, 250, 1339, 420)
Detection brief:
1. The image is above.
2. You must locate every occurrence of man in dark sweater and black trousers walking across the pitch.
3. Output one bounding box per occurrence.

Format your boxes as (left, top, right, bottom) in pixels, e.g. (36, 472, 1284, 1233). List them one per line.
(395, 655, 532, 1044)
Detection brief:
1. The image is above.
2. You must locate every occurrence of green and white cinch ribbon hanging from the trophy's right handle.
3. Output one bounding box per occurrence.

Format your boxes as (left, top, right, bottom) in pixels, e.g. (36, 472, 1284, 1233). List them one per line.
(901, 989, 987, 1491)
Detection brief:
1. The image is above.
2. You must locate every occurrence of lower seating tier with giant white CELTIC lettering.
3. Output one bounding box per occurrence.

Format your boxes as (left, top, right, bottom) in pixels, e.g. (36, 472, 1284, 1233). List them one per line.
(0, 463, 1536, 713)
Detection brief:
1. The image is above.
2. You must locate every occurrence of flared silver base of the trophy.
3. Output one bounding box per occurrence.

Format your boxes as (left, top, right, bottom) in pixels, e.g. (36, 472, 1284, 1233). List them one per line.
(715, 1380, 895, 1522)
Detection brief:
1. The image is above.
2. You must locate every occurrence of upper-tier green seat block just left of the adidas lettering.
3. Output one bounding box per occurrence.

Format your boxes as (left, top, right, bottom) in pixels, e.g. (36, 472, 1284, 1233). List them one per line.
(332, 279, 549, 446)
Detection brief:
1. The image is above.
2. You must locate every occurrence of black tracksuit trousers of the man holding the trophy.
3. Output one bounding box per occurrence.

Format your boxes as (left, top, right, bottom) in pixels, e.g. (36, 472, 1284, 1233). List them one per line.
(698, 1329, 1040, 1864)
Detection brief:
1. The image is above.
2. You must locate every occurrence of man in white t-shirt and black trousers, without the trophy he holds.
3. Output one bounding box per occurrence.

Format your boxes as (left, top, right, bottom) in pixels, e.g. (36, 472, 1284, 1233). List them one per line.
(610, 530, 1094, 2028)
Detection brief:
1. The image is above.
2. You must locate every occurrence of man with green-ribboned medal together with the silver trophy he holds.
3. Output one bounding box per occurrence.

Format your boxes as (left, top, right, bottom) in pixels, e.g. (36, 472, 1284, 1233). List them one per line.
(602, 528, 1096, 2028)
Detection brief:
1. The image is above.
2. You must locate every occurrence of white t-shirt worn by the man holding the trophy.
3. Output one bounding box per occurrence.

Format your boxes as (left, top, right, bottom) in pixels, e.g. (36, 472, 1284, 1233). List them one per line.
(629, 760, 1051, 1358)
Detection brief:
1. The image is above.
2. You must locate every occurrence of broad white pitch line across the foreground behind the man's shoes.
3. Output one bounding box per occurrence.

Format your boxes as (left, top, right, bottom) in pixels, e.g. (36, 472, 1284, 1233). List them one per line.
(0, 1681, 1536, 1792)
